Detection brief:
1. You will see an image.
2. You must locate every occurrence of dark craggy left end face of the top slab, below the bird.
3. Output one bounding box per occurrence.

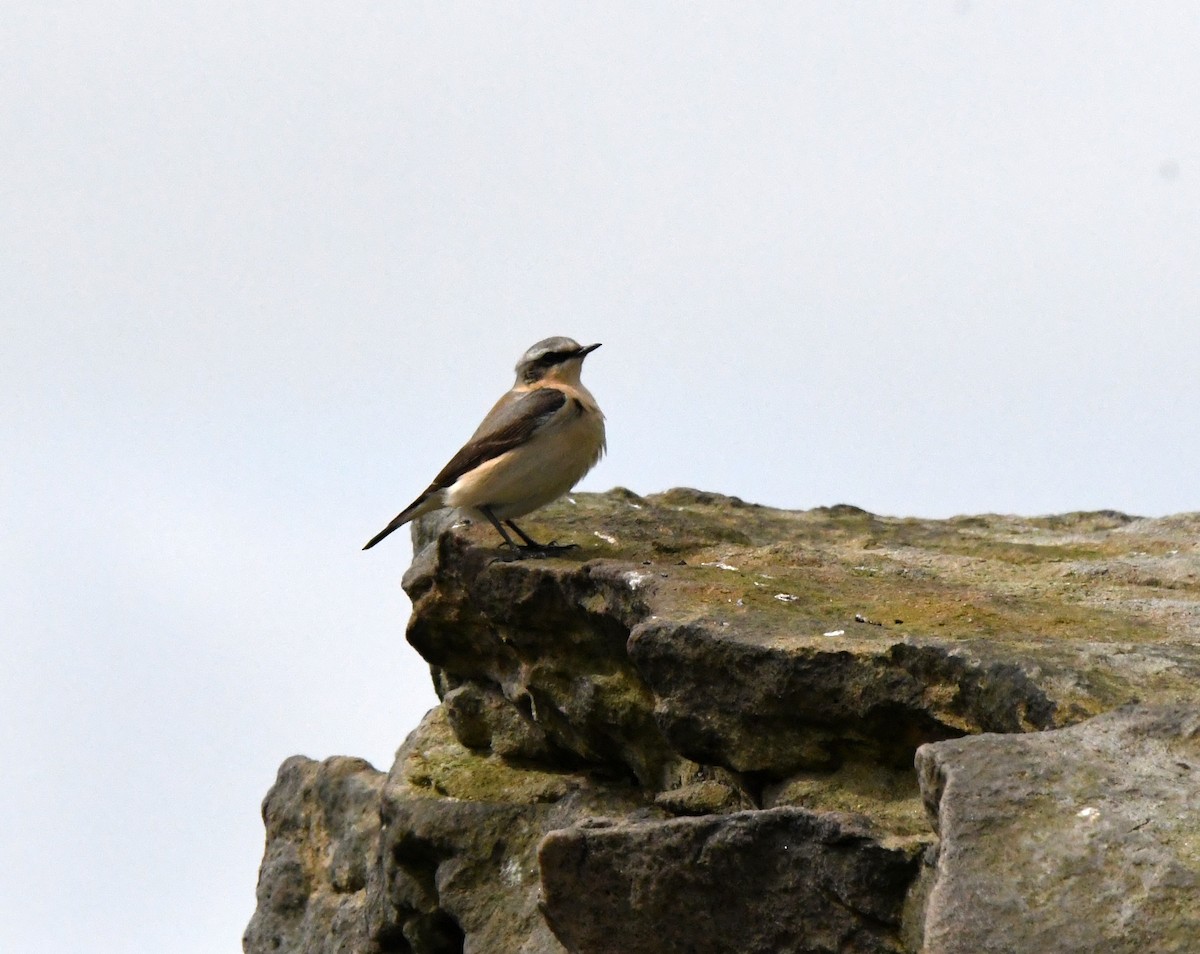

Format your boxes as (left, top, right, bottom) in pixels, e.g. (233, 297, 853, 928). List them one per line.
(404, 533, 678, 785)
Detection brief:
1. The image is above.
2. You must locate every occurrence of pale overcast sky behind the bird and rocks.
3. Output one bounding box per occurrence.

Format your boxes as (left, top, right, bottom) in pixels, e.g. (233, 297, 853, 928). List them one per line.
(7, 0, 1200, 954)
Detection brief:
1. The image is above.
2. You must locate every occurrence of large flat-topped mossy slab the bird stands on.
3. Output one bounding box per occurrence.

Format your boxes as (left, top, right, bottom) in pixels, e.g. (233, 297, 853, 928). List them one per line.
(406, 491, 1200, 787)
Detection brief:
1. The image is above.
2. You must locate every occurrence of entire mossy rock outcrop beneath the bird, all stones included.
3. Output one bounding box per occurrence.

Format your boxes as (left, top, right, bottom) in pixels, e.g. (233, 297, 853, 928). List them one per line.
(245, 491, 1200, 954)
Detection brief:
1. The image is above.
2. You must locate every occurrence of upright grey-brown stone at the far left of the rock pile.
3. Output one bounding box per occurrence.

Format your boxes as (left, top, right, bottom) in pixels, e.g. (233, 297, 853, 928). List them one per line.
(242, 756, 384, 954)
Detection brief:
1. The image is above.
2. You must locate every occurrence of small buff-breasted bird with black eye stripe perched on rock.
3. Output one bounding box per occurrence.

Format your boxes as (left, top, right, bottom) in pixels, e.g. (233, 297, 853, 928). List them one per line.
(362, 337, 605, 556)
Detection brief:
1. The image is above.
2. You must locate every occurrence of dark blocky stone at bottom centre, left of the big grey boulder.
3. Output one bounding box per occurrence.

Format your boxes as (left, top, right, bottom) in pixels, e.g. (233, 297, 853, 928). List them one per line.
(539, 809, 917, 954)
